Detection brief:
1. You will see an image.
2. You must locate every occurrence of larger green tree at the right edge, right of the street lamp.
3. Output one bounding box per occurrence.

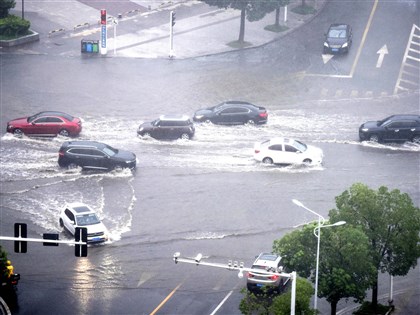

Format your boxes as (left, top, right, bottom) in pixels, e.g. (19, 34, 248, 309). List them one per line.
(329, 183, 420, 309)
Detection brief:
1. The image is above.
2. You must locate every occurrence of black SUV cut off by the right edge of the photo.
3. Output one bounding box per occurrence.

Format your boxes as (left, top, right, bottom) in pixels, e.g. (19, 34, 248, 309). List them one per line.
(359, 115, 420, 144)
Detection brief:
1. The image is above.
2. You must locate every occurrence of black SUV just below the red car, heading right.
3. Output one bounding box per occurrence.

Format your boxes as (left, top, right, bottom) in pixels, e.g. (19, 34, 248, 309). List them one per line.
(58, 141, 136, 171)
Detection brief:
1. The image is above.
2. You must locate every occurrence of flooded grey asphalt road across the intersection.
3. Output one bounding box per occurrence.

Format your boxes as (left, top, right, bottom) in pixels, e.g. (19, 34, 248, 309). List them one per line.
(0, 2, 420, 314)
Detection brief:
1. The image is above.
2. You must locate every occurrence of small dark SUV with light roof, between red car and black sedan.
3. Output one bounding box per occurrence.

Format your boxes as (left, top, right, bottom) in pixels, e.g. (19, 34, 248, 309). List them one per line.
(137, 115, 195, 140)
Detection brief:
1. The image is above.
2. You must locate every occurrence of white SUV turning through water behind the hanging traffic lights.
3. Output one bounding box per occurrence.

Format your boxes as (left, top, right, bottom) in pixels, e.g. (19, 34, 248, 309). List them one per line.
(59, 202, 108, 243)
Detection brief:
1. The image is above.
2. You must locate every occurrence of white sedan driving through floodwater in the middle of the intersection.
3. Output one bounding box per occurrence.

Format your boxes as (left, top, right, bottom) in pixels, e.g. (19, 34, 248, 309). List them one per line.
(254, 138, 324, 165)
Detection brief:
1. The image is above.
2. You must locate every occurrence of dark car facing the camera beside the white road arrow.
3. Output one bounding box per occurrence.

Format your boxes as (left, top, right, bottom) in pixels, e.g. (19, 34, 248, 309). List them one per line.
(324, 24, 353, 54)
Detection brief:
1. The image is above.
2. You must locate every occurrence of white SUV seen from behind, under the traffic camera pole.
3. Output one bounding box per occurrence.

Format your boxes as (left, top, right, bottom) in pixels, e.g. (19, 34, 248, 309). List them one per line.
(247, 253, 287, 292)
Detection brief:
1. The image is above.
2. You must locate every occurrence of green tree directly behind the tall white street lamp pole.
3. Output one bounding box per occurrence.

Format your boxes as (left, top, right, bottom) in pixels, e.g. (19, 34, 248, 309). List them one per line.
(273, 224, 375, 314)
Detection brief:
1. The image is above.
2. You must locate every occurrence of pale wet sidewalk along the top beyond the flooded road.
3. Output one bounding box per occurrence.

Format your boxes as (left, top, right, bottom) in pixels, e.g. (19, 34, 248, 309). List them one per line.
(11, 0, 326, 59)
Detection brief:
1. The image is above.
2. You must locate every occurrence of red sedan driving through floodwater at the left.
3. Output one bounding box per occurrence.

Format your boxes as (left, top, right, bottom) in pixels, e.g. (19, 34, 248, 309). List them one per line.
(7, 111, 82, 137)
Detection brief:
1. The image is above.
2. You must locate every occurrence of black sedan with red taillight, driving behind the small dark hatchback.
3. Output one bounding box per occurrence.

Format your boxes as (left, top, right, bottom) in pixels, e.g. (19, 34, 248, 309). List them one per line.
(193, 101, 268, 125)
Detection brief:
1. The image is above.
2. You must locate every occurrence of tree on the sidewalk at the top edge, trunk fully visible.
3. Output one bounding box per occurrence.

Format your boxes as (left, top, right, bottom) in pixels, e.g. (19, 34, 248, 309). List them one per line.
(201, 0, 274, 43)
